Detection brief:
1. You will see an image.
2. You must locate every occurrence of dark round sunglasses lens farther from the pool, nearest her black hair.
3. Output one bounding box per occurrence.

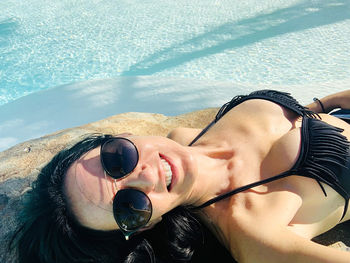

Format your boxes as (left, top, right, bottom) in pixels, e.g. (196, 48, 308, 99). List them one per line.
(113, 189, 152, 231)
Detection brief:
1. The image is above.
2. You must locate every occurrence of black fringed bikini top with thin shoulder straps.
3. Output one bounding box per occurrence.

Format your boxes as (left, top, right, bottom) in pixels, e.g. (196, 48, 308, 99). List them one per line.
(189, 90, 350, 220)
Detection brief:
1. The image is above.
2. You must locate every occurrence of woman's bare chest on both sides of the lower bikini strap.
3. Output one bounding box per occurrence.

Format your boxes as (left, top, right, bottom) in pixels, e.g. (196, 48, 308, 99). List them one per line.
(202, 106, 343, 225)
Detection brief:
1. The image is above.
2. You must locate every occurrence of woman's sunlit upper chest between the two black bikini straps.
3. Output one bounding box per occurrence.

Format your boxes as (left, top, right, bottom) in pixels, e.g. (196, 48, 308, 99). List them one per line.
(203, 101, 301, 189)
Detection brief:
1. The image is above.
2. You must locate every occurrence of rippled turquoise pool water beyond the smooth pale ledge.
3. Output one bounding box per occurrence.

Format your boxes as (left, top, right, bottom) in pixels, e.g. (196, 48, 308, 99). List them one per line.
(0, 0, 350, 105)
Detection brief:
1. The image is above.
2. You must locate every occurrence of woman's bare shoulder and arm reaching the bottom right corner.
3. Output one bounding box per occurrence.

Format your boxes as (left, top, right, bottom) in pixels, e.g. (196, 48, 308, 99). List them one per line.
(228, 191, 350, 263)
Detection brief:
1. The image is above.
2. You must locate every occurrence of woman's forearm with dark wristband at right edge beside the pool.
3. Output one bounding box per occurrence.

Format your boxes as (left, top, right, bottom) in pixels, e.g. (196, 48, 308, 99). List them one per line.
(306, 90, 350, 113)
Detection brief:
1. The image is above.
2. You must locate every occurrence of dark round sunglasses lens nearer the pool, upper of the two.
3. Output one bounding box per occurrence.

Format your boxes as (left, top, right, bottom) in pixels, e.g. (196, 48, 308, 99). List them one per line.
(101, 138, 139, 179)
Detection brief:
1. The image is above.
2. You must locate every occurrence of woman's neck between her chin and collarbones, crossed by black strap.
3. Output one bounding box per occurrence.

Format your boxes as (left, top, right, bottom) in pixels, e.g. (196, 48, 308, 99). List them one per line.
(183, 141, 237, 256)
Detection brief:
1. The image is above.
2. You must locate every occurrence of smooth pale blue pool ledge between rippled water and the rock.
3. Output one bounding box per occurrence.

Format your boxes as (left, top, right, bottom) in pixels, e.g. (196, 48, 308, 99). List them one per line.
(0, 76, 241, 151)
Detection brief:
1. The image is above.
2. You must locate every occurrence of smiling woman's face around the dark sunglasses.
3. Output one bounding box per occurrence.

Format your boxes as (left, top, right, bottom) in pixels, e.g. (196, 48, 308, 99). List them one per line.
(65, 136, 196, 230)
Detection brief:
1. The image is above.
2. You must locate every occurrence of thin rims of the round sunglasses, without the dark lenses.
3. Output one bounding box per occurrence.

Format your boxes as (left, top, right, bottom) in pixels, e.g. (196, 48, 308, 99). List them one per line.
(100, 137, 153, 240)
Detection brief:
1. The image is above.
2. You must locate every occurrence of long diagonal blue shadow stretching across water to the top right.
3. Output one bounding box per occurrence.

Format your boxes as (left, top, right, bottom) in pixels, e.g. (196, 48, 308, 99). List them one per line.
(122, 0, 350, 76)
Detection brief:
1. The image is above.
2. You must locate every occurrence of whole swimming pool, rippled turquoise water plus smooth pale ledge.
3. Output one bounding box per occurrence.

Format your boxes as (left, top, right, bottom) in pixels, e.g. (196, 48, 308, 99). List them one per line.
(0, 0, 350, 151)
